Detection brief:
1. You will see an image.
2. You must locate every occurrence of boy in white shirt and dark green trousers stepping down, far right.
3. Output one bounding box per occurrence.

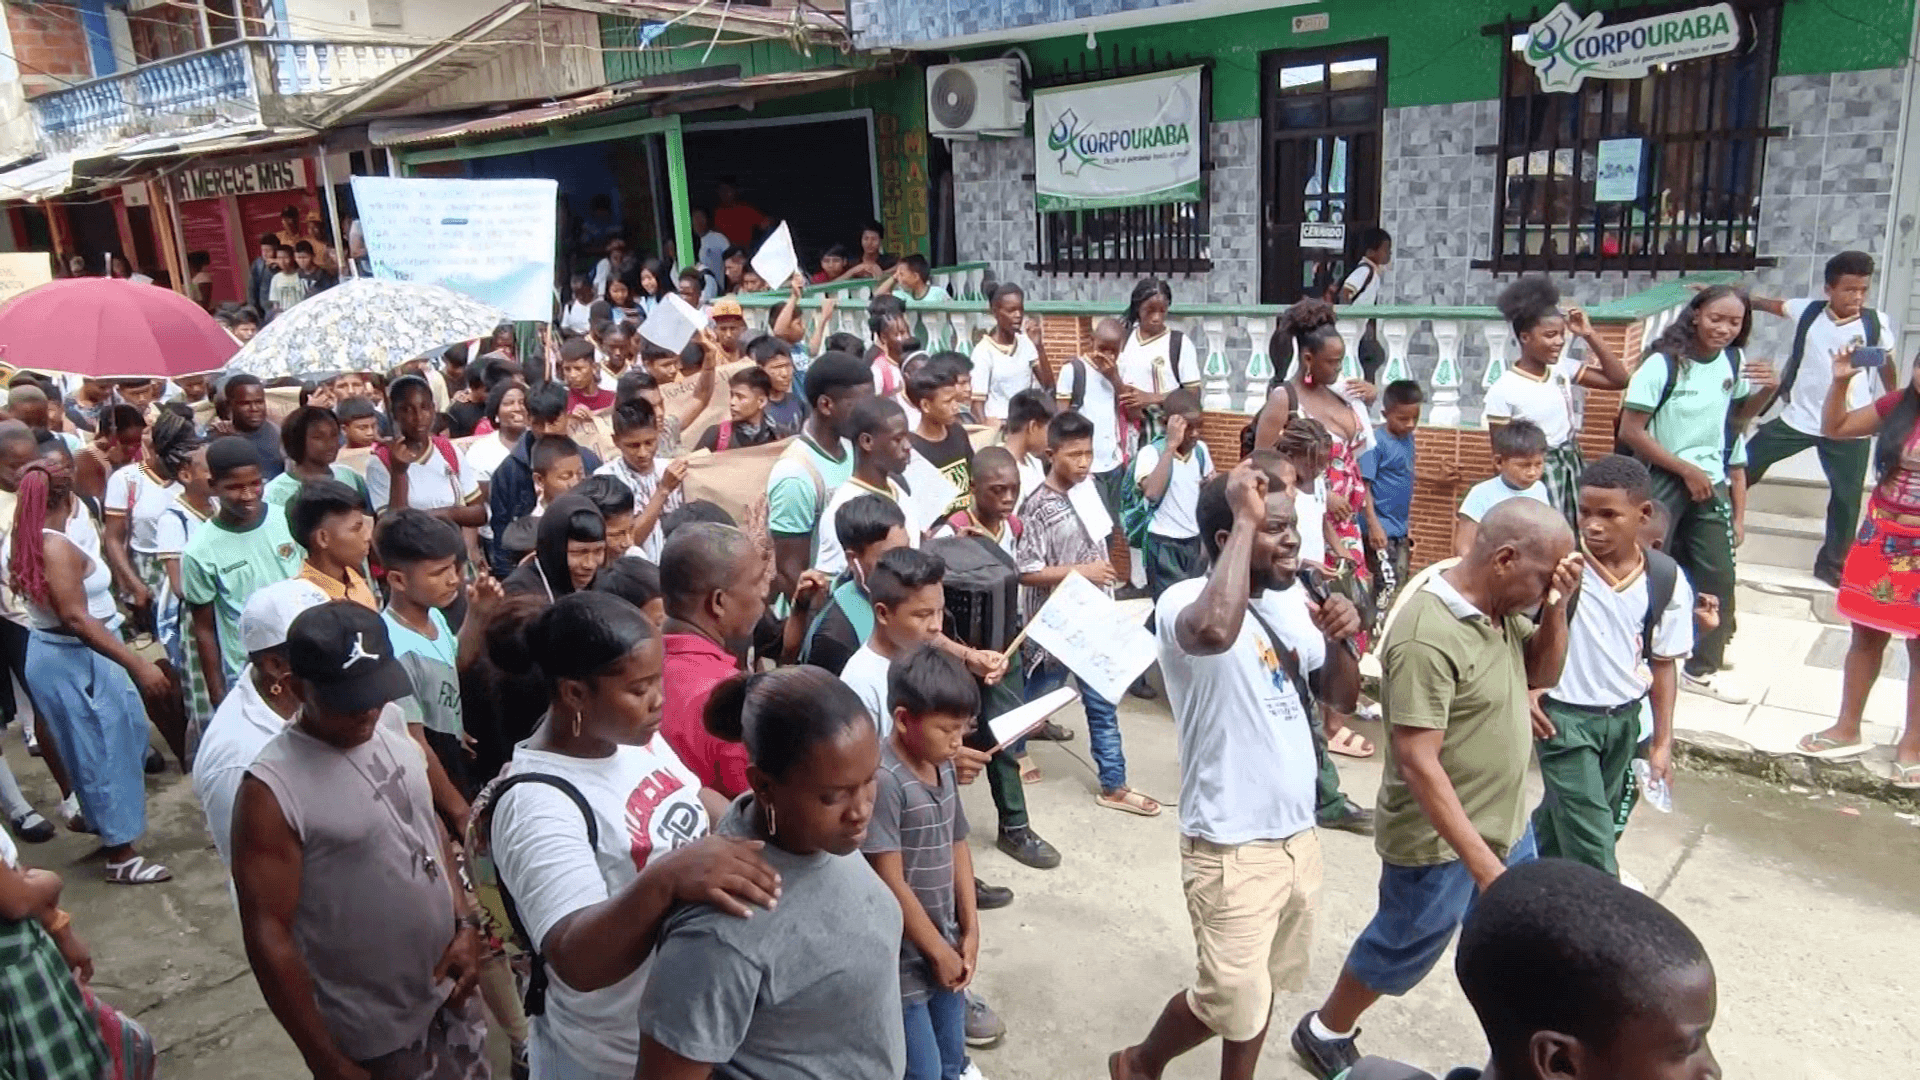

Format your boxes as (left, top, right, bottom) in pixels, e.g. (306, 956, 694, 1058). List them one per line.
(1747, 252, 1901, 588)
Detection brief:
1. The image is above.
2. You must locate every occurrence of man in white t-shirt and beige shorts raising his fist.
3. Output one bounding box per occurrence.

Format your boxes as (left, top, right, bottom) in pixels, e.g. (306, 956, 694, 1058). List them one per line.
(1110, 461, 1359, 1076)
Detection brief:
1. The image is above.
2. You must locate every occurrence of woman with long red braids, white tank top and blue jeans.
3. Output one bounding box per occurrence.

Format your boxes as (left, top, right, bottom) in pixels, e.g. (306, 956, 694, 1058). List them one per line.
(4, 442, 173, 884)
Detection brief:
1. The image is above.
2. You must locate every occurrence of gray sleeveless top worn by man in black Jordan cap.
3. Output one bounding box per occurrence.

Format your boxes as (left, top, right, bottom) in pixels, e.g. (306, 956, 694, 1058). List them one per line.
(248, 724, 453, 1061)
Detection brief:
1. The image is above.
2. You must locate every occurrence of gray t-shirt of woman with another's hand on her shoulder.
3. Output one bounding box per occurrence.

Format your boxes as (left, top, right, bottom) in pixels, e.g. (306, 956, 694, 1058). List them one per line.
(639, 792, 906, 1080)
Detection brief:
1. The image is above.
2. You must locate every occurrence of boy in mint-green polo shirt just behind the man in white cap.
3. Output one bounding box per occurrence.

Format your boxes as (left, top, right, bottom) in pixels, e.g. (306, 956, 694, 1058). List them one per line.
(180, 434, 305, 705)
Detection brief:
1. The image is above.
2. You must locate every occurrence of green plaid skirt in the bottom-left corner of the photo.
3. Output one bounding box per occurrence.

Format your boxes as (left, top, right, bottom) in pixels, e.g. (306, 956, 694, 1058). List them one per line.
(0, 919, 109, 1080)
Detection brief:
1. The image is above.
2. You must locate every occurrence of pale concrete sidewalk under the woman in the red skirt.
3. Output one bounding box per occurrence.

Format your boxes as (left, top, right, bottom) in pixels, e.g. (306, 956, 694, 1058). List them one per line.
(1674, 582, 1916, 801)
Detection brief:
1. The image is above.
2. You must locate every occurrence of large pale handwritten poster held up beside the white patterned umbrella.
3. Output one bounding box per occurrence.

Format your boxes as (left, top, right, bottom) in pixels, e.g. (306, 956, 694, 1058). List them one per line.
(353, 177, 559, 321)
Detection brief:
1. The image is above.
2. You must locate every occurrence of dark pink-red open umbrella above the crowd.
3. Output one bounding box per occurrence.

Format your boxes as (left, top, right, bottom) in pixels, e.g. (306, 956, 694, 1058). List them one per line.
(0, 277, 240, 379)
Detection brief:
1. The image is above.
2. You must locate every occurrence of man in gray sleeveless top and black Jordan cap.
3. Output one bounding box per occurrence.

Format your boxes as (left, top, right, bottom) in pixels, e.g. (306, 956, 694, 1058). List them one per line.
(232, 600, 488, 1080)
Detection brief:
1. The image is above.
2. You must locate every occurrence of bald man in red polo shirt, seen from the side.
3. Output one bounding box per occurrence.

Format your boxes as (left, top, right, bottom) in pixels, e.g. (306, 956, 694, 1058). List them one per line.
(660, 521, 772, 799)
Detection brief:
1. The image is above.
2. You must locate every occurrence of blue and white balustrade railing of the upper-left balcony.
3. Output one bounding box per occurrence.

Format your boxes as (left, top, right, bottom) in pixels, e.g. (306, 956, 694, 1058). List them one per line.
(31, 38, 424, 154)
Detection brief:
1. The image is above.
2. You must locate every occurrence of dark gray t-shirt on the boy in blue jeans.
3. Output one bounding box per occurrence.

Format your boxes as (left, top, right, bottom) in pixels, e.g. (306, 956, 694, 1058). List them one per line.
(860, 740, 972, 1005)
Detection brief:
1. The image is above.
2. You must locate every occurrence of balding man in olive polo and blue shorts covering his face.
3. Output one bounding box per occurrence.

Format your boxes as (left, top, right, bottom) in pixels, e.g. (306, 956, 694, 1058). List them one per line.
(1292, 500, 1582, 1080)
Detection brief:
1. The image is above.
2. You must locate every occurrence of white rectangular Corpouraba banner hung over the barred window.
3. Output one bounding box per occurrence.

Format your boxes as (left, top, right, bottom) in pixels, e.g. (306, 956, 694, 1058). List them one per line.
(1033, 67, 1206, 209)
